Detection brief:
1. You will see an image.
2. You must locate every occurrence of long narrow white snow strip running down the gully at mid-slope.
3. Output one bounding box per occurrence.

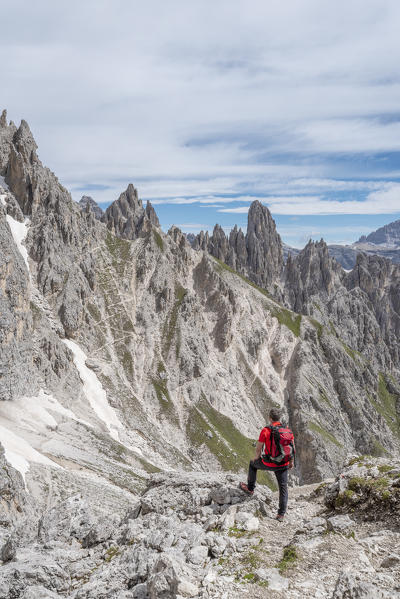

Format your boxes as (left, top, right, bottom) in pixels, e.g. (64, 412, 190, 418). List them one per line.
(63, 339, 123, 442)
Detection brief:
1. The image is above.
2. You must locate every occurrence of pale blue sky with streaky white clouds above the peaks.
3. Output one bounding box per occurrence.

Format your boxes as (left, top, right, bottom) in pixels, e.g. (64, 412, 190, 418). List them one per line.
(0, 0, 400, 247)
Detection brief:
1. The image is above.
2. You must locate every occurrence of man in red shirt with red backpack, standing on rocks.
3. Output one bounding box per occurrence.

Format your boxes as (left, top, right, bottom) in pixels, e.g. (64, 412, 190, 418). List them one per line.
(239, 408, 296, 522)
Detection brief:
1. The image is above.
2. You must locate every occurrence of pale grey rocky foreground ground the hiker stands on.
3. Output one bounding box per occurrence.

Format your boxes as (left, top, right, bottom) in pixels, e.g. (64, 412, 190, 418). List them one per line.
(0, 458, 400, 599)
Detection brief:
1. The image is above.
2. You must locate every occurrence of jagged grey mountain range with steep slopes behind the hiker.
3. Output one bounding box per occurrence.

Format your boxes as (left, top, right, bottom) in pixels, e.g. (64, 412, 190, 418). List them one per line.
(0, 106, 400, 528)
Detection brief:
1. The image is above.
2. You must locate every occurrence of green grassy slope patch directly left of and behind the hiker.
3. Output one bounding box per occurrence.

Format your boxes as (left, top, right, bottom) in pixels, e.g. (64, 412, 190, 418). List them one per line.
(186, 396, 276, 490)
